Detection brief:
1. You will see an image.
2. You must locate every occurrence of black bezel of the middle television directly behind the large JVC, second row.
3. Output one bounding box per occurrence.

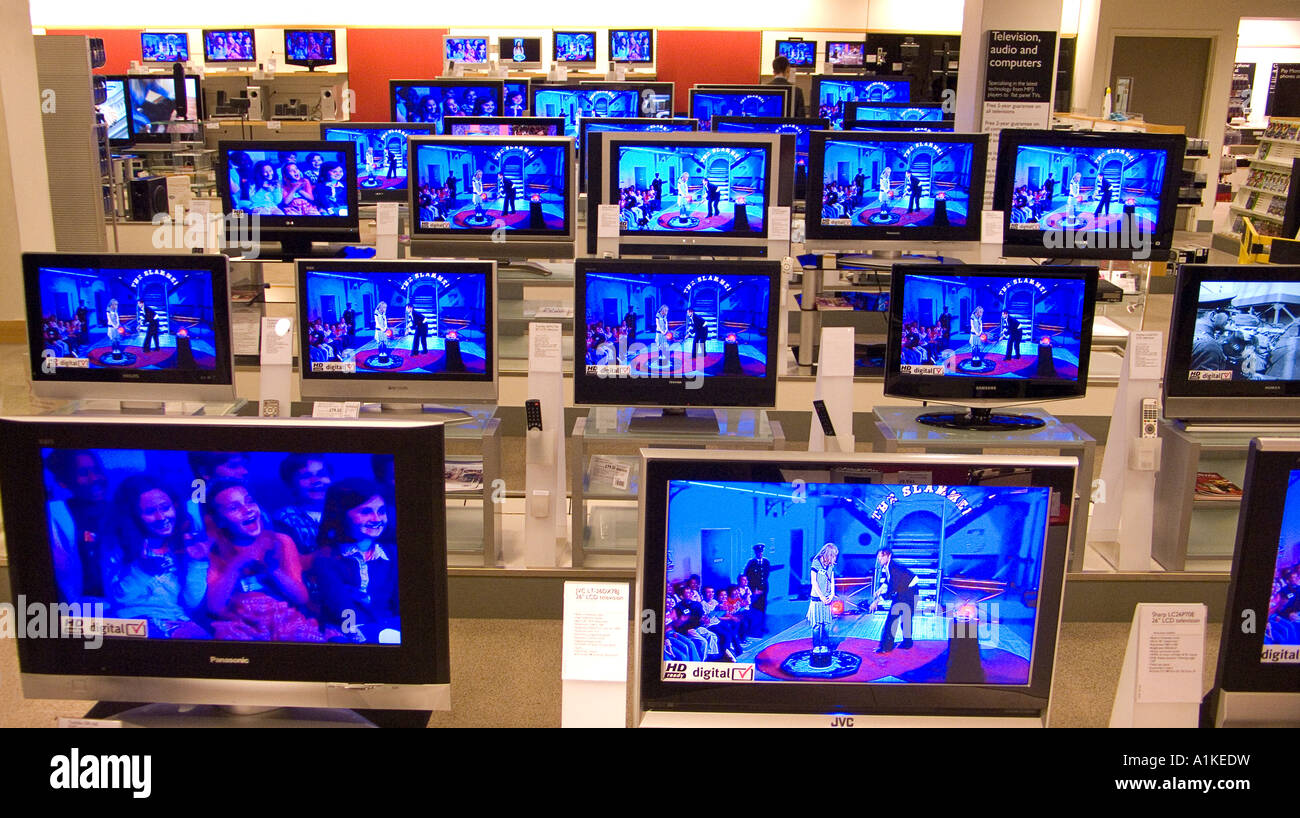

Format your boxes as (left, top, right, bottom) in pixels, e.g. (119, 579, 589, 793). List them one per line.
(573, 257, 783, 408)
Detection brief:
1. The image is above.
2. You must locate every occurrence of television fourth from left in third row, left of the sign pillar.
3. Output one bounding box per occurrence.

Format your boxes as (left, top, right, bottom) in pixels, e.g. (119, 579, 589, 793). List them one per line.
(806, 131, 988, 248)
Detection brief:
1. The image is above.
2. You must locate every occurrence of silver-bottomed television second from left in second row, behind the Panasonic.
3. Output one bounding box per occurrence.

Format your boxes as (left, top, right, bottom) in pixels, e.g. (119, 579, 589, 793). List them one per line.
(298, 259, 497, 402)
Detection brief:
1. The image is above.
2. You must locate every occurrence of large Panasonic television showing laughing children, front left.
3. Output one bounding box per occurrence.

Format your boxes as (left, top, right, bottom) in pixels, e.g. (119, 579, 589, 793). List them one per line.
(0, 417, 450, 710)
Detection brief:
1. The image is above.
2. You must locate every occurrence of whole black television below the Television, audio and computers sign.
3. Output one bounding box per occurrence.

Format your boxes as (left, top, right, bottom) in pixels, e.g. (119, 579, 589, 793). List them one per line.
(993, 129, 1187, 260)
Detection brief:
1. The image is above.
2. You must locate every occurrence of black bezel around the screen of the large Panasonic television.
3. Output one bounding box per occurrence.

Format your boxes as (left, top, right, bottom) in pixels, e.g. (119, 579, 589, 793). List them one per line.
(0, 417, 450, 694)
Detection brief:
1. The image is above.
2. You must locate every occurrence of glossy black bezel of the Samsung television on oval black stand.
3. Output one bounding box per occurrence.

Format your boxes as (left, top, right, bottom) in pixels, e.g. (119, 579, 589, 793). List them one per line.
(884, 264, 1099, 406)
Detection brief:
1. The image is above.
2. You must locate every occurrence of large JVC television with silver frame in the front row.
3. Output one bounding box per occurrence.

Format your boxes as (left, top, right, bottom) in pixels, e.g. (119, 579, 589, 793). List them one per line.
(633, 449, 1086, 727)
